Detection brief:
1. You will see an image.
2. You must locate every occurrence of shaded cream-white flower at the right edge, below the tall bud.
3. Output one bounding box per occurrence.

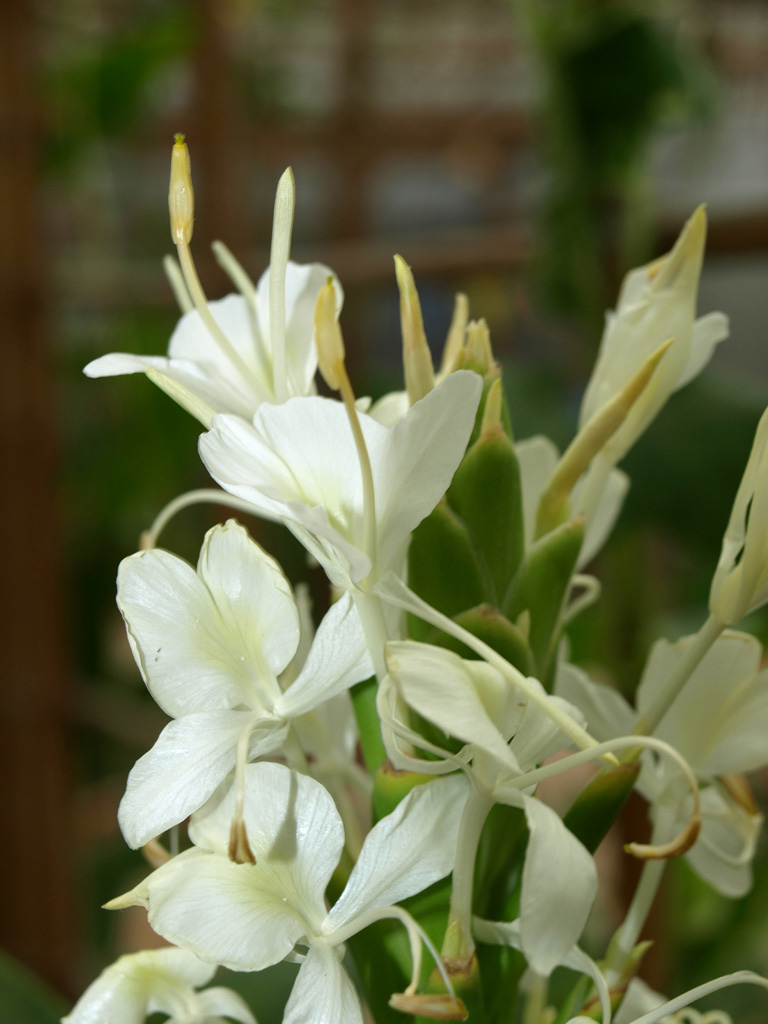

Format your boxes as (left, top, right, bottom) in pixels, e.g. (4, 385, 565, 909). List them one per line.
(556, 631, 768, 897)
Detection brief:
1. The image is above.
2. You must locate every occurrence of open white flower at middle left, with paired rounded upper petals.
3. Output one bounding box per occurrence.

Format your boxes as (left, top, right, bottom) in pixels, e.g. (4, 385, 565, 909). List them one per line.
(118, 519, 373, 848)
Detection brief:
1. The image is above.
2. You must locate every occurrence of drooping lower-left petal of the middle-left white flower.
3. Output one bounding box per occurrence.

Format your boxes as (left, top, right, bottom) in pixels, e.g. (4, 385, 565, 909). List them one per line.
(118, 711, 288, 850)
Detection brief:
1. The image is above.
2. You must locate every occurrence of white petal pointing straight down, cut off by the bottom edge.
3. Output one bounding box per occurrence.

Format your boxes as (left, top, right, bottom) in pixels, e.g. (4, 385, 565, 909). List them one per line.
(283, 942, 362, 1024)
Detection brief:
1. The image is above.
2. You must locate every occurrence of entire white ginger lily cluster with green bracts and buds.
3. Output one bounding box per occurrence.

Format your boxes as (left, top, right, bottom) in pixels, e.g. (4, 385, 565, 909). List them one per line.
(65, 137, 768, 1024)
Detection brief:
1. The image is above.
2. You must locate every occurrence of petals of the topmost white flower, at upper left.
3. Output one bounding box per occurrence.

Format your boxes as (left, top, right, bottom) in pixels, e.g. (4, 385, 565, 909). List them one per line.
(85, 262, 343, 426)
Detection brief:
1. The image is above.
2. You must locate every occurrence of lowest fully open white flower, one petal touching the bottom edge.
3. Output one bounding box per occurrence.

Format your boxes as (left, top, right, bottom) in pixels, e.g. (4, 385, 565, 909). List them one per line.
(109, 762, 468, 1024)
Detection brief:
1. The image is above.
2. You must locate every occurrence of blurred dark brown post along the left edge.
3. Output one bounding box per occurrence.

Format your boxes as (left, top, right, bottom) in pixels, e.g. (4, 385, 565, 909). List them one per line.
(0, 2, 74, 990)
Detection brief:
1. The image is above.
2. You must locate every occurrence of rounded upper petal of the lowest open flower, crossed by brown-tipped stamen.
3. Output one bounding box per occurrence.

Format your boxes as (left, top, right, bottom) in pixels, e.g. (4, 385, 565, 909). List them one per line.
(189, 762, 344, 924)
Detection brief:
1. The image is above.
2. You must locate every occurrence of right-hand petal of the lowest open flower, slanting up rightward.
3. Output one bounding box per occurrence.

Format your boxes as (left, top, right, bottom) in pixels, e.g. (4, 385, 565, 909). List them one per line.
(325, 775, 468, 933)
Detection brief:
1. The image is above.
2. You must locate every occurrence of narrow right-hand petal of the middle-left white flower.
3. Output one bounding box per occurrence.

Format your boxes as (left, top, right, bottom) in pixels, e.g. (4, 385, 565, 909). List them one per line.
(275, 594, 374, 718)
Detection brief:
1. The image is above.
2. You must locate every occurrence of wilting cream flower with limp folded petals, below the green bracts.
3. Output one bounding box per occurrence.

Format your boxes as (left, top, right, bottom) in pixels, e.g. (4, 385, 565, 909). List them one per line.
(378, 641, 597, 975)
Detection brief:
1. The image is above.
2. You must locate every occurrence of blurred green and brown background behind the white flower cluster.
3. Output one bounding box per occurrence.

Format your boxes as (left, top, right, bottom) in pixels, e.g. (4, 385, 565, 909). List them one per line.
(6, 0, 768, 1024)
